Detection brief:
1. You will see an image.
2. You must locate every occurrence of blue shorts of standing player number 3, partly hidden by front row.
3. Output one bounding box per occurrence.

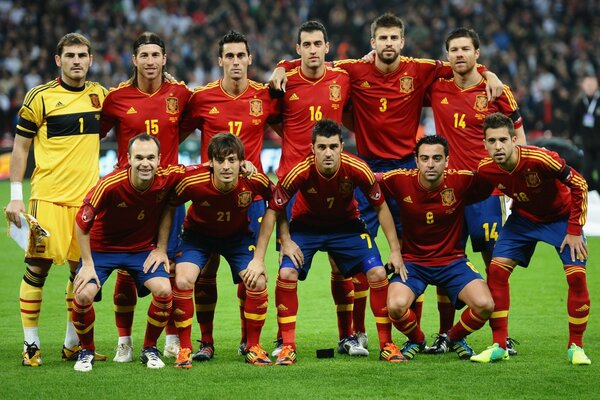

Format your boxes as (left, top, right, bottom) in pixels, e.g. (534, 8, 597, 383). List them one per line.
(354, 155, 417, 237)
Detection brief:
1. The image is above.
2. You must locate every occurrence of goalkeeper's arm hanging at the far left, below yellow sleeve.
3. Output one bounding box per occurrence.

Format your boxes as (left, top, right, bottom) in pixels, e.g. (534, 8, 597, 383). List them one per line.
(6, 135, 33, 228)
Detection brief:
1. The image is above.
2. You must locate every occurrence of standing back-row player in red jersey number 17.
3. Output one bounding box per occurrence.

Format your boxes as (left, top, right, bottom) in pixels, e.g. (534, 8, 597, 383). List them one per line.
(181, 31, 277, 361)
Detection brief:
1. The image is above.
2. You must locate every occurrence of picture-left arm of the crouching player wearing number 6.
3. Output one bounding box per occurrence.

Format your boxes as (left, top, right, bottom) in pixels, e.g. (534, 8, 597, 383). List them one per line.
(73, 203, 100, 293)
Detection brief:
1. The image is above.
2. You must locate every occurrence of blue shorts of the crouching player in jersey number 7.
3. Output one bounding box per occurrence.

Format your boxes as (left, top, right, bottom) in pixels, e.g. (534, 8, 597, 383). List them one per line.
(279, 219, 383, 281)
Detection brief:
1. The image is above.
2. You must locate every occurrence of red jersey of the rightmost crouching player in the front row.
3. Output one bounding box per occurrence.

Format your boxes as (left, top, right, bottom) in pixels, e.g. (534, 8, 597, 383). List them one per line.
(478, 146, 587, 235)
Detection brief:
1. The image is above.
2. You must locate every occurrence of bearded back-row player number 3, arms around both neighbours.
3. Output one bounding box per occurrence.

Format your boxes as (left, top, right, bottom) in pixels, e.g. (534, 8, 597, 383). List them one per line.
(272, 13, 503, 236)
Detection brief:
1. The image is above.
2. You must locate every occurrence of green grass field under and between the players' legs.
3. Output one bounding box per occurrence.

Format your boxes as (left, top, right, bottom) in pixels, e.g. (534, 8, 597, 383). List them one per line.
(0, 182, 600, 399)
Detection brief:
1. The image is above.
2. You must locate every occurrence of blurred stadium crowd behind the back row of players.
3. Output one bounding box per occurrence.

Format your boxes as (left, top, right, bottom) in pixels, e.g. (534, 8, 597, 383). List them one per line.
(0, 0, 600, 147)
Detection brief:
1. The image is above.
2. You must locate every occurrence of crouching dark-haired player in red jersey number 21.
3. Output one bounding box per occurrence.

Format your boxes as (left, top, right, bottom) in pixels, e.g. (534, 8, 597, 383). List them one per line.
(166, 133, 272, 368)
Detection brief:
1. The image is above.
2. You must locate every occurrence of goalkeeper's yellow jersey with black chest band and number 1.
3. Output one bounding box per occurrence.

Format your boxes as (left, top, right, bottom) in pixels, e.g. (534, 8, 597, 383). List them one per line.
(16, 78, 107, 206)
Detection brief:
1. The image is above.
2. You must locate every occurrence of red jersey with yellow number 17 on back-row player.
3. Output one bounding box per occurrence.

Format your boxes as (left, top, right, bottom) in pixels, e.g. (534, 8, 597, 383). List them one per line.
(181, 80, 278, 172)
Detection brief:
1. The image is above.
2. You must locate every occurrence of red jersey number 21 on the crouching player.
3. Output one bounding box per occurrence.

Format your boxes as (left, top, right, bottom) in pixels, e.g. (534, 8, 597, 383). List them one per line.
(171, 165, 273, 238)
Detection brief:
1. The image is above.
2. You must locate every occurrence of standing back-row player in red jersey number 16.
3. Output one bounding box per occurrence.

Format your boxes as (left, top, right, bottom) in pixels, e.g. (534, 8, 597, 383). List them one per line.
(273, 21, 369, 356)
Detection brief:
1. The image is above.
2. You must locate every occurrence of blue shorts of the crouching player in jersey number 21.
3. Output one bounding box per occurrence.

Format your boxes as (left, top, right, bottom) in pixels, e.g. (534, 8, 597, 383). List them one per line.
(176, 229, 255, 284)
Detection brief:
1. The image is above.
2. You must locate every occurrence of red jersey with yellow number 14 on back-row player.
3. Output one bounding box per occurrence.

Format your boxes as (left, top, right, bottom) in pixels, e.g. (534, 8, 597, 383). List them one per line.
(428, 78, 523, 171)
